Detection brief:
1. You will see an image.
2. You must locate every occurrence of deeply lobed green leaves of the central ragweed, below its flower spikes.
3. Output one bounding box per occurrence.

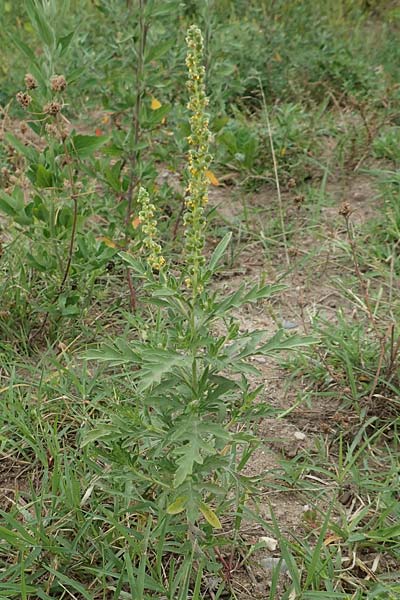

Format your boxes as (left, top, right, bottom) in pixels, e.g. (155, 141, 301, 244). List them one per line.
(81, 246, 315, 522)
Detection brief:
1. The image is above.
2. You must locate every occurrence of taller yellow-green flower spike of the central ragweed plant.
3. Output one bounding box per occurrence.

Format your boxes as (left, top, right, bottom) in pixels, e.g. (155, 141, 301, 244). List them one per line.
(184, 25, 212, 294)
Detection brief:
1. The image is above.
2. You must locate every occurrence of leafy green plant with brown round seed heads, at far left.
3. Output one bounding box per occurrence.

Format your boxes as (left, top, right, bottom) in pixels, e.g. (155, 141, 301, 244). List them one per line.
(0, 1, 120, 338)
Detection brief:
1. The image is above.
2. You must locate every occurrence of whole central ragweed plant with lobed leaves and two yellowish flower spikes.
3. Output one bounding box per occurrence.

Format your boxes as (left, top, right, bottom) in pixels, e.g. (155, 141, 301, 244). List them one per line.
(83, 27, 314, 576)
